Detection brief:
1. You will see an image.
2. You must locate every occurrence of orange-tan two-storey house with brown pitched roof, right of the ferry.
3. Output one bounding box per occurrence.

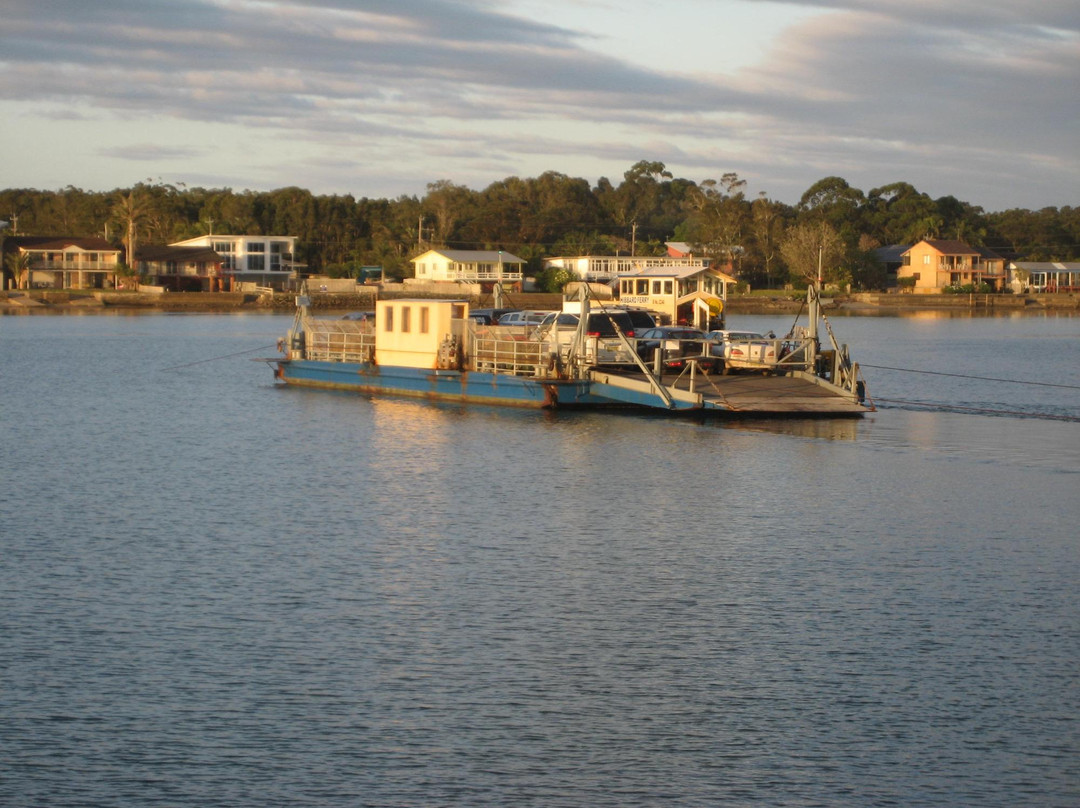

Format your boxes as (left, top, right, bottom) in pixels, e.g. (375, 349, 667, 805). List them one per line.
(896, 239, 1005, 293)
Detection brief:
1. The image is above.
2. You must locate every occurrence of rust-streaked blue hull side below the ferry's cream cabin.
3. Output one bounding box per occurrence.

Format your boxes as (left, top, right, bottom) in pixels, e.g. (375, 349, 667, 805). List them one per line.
(274, 360, 611, 408)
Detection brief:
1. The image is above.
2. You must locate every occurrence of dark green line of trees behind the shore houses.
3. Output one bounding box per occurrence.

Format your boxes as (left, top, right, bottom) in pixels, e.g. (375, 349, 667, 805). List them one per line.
(0, 160, 1080, 289)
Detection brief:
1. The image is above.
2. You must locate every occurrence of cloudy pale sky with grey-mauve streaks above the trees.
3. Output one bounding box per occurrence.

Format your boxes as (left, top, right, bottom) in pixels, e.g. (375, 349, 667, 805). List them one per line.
(0, 0, 1080, 212)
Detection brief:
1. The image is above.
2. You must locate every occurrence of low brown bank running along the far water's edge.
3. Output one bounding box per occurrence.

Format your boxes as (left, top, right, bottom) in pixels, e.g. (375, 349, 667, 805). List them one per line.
(0, 287, 1080, 315)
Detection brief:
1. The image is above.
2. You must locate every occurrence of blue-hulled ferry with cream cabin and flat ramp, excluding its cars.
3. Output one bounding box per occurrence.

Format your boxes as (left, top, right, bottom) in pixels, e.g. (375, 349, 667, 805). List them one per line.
(267, 284, 873, 417)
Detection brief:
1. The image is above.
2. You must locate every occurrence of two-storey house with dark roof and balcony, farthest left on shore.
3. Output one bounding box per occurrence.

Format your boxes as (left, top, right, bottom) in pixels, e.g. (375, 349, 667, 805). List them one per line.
(3, 235, 122, 289)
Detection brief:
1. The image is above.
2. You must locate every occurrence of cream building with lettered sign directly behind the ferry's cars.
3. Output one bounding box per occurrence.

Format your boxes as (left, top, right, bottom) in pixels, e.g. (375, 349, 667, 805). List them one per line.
(619, 266, 738, 328)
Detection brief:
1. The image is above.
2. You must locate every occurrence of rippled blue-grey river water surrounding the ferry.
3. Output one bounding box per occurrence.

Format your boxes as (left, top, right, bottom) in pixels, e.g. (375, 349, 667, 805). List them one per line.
(0, 313, 1080, 808)
